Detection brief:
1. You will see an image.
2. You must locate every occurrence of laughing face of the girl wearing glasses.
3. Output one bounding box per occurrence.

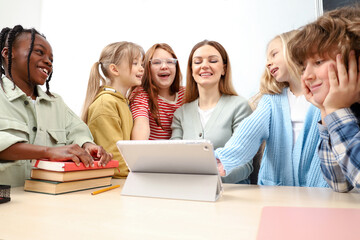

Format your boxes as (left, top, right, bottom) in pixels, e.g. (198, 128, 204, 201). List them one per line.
(150, 48, 176, 90)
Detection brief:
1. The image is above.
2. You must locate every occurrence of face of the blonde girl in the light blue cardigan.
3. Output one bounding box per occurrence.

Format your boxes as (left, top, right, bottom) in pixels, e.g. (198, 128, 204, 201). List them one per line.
(266, 37, 290, 82)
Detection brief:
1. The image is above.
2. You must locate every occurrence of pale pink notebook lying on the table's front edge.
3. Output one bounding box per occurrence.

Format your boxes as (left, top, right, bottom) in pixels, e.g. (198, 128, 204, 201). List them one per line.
(257, 207, 360, 240)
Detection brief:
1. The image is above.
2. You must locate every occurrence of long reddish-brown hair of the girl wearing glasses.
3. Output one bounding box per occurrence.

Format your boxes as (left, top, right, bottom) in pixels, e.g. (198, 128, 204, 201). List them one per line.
(130, 43, 182, 127)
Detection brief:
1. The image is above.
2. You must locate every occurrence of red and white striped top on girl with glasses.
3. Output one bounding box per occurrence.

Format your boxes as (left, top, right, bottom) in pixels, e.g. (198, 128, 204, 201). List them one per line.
(130, 87, 185, 140)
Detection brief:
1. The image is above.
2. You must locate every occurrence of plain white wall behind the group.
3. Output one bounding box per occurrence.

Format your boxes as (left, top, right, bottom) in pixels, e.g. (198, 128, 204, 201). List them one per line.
(0, 0, 316, 114)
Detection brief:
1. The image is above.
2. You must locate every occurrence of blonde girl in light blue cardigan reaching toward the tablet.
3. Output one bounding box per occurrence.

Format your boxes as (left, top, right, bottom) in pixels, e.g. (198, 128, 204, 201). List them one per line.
(215, 31, 328, 187)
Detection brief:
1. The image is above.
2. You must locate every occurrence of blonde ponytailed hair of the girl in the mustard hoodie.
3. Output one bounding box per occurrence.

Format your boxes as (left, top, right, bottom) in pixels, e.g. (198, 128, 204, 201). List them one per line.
(81, 41, 145, 123)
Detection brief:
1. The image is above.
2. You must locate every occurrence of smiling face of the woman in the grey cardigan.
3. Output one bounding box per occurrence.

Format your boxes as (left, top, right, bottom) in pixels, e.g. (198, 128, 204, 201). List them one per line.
(191, 45, 225, 87)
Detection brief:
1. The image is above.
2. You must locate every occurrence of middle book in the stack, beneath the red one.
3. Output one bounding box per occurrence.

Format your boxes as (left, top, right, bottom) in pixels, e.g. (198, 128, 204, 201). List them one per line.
(31, 168, 114, 182)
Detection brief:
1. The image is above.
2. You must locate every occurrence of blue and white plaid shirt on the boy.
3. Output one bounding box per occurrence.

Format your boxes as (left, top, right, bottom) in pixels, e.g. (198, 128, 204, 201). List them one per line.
(319, 108, 360, 192)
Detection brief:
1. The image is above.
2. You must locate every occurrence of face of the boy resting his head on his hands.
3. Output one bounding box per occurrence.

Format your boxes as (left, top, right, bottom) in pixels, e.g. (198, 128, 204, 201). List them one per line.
(301, 55, 336, 105)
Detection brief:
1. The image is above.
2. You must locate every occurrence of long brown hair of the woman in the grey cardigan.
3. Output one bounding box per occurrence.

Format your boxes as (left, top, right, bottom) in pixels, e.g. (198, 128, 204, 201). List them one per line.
(185, 40, 238, 103)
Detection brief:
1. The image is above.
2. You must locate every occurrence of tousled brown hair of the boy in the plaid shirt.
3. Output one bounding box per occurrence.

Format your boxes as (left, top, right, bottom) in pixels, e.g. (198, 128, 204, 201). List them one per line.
(289, 4, 360, 69)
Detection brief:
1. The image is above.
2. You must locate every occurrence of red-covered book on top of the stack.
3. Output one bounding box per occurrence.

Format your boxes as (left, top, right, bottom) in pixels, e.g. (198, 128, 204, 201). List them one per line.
(31, 159, 119, 172)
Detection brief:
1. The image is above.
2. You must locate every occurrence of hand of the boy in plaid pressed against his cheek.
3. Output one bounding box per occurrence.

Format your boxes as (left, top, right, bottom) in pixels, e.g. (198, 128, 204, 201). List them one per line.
(323, 51, 360, 114)
